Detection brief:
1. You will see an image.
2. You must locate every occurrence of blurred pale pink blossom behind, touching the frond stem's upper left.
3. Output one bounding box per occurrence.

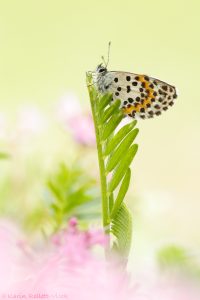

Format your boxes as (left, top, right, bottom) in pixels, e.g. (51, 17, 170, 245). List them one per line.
(58, 93, 95, 146)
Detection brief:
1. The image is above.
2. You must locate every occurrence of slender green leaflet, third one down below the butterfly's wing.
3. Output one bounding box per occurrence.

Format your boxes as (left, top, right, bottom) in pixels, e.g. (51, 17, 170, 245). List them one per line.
(108, 144, 138, 193)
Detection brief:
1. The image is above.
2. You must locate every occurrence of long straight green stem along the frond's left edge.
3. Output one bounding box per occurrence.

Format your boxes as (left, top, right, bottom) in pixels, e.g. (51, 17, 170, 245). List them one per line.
(89, 90, 110, 235)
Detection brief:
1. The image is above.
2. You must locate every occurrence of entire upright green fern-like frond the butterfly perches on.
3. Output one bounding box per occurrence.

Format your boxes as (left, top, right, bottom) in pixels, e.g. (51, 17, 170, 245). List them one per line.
(87, 77, 138, 257)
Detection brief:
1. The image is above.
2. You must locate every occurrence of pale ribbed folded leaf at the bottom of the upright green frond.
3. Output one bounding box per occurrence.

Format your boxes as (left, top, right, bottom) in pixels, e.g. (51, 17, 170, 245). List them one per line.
(111, 203, 132, 257)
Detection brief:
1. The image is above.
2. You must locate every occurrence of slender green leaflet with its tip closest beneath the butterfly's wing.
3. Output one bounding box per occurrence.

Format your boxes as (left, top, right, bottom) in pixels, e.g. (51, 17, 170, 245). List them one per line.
(104, 121, 137, 155)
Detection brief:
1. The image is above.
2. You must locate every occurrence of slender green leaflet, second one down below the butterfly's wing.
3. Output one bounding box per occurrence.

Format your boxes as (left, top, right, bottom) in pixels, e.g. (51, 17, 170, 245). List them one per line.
(106, 128, 139, 173)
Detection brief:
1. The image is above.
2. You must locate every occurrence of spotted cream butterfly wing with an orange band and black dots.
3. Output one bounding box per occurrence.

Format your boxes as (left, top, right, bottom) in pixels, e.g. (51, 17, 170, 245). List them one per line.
(109, 72, 177, 119)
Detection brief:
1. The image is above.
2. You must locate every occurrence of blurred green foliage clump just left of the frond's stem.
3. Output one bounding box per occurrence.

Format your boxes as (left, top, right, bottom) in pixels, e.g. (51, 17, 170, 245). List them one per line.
(46, 163, 101, 230)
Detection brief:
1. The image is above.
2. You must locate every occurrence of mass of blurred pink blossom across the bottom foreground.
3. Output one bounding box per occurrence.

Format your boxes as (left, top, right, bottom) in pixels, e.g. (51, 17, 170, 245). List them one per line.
(0, 218, 200, 300)
